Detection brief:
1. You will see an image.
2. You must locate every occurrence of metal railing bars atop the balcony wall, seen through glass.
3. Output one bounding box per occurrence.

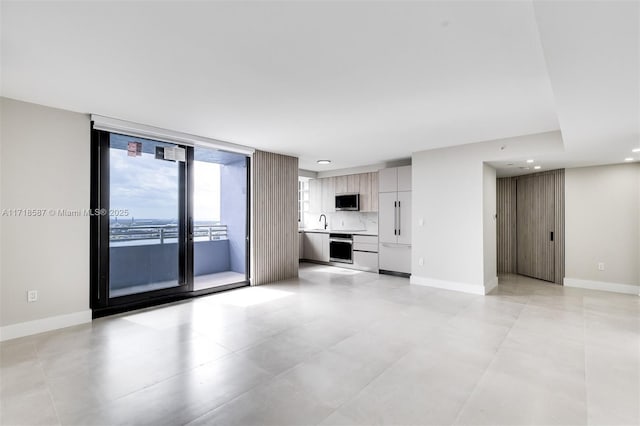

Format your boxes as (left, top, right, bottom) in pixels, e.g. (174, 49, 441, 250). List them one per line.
(109, 225, 227, 244)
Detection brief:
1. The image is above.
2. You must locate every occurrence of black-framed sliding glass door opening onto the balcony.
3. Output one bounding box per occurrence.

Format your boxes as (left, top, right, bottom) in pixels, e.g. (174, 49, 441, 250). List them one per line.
(91, 130, 249, 316)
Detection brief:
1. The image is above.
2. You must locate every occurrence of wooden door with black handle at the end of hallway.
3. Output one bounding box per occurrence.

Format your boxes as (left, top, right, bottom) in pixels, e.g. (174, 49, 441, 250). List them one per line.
(516, 174, 555, 282)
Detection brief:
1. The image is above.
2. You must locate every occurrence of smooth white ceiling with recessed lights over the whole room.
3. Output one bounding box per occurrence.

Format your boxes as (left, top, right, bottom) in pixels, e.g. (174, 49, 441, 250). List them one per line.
(1, 1, 640, 173)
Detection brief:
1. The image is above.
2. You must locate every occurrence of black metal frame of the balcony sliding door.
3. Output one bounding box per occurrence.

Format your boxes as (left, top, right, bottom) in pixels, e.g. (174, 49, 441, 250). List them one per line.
(90, 123, 251, 318)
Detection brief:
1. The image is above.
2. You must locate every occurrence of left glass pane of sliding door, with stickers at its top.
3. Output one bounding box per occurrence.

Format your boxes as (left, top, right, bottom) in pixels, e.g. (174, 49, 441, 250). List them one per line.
(108, 133, 185, 298)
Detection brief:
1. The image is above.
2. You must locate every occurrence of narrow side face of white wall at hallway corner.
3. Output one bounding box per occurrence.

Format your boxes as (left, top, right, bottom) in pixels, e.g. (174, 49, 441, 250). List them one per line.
(482, 164, 498, 290)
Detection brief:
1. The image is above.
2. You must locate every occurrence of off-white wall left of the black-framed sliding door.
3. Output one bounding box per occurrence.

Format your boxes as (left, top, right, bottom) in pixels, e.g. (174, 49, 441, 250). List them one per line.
(0, 98, 91, 339)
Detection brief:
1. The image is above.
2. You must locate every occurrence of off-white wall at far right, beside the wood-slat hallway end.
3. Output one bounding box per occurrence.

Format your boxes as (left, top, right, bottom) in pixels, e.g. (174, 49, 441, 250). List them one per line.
(565, 163, 640, 286)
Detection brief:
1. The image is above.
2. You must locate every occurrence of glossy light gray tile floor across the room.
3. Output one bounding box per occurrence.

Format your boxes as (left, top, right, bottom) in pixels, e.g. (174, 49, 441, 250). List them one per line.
(0, 264, 640, 425)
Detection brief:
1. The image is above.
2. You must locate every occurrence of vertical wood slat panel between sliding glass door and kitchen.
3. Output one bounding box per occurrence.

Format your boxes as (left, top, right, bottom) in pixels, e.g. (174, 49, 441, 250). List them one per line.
(251, 151, 299, 285)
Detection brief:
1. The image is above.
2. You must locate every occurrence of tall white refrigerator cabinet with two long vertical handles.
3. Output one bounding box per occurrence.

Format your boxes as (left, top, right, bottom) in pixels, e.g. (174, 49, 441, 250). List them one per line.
(378, 166, 411, 274)
